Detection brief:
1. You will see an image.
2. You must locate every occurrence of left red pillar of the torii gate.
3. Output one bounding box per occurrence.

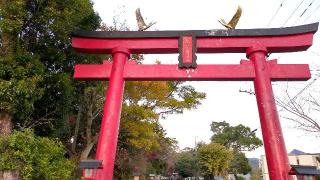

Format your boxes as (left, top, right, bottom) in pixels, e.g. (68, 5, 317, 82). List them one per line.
(96, 48, 129, 180)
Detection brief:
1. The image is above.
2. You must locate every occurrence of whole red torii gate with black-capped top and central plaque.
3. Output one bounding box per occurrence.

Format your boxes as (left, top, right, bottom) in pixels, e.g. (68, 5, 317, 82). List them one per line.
(72, 23, 318, 180)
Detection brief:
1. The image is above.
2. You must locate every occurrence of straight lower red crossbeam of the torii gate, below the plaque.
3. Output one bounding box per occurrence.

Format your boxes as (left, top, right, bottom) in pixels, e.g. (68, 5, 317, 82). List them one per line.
(74, 61, 310, 81)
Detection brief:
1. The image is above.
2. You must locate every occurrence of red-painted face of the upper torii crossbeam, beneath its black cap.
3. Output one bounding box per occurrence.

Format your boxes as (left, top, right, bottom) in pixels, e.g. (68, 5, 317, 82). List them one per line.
(72, 33, 313, 54)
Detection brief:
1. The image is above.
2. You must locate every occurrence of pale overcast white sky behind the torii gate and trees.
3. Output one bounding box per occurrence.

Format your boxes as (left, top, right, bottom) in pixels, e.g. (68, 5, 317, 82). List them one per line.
(93, 0, 320, 157)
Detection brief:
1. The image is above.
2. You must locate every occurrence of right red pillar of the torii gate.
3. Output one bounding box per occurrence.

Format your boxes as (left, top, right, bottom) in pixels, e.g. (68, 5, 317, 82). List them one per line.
(247, 47, 291, 180)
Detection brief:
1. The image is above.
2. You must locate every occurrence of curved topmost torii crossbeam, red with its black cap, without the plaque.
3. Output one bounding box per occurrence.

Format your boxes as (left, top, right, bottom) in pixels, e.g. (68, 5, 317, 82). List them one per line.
(72, 23, 318, 54)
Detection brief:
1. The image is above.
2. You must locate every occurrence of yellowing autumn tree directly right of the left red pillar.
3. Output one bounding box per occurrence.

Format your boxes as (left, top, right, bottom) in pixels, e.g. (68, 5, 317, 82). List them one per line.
(115, 81, 205, 179)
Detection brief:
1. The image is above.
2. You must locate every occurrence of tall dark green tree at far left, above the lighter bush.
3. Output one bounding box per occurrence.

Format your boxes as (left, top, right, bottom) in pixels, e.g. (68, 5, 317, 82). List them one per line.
(0, 0, 100, 129)
